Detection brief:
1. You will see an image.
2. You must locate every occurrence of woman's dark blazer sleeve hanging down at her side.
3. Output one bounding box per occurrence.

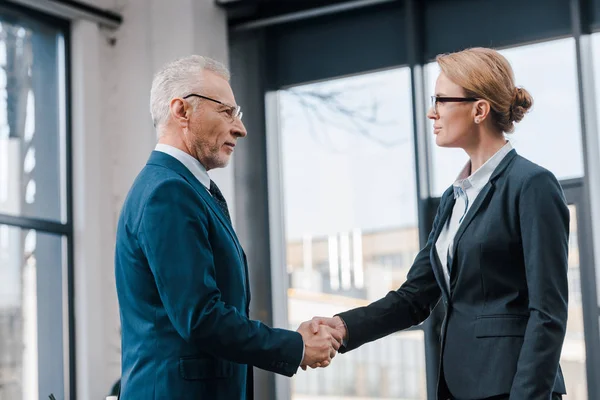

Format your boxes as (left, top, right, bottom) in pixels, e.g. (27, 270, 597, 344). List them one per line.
(510, 171, 569, 400)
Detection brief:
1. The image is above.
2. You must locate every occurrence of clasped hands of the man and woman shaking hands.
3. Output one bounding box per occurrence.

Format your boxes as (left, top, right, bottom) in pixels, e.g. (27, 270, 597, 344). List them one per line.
(297, 316, 348, 371)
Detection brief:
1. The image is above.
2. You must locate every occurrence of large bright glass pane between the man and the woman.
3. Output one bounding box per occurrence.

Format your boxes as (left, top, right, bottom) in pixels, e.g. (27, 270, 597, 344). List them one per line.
(279, 68, 426, 400)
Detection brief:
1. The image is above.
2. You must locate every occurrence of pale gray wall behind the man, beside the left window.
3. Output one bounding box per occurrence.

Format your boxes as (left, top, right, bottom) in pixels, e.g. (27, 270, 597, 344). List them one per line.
(70, 0, 233, 399)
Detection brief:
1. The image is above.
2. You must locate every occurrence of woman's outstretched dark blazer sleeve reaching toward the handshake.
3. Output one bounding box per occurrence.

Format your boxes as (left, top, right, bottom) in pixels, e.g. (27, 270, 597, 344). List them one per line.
(337, 192, 448, 353)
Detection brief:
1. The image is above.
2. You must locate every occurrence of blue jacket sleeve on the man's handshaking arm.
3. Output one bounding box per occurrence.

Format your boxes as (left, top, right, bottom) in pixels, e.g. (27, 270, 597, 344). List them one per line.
(138, 180, 304, 376)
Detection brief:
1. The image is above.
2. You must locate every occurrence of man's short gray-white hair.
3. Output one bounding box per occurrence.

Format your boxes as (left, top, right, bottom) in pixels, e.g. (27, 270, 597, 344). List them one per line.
(150, 55, 230, 128)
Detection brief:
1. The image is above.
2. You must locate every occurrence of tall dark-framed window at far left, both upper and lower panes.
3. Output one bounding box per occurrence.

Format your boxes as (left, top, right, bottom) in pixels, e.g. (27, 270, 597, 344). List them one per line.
(0, 6, 72, 399)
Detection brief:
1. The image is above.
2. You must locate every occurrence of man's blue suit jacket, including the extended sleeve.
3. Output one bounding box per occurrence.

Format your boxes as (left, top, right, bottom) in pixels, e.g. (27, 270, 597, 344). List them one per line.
(115, 151, 304, 400)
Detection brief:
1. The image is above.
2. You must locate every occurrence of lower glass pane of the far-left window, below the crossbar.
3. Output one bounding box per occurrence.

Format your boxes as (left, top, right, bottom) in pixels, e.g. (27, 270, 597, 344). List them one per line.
(0, 225, 65, 400)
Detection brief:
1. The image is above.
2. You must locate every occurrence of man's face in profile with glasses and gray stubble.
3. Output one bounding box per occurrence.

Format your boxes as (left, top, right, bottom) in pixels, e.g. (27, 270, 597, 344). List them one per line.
(188, 71, 246, 170)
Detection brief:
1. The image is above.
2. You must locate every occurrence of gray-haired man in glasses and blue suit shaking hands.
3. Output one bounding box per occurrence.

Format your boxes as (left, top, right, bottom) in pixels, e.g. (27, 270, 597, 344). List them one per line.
(115, 56, 341, 400)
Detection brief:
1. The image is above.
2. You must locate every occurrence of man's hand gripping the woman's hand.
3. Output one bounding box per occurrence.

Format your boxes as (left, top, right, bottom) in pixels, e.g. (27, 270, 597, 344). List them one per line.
(298, 321, 342, 370)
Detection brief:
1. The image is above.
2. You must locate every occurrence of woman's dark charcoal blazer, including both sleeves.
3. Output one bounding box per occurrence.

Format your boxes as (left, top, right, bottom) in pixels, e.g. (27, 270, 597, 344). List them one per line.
(340, 150, 569, 400)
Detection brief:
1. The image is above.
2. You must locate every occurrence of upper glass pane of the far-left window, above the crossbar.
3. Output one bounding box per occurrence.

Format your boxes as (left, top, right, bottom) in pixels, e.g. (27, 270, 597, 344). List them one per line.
(0, 14, 65, 222)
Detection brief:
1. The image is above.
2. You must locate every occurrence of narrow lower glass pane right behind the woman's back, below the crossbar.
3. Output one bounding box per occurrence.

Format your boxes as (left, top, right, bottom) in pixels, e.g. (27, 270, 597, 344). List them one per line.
(560, 205, 588, 400)
